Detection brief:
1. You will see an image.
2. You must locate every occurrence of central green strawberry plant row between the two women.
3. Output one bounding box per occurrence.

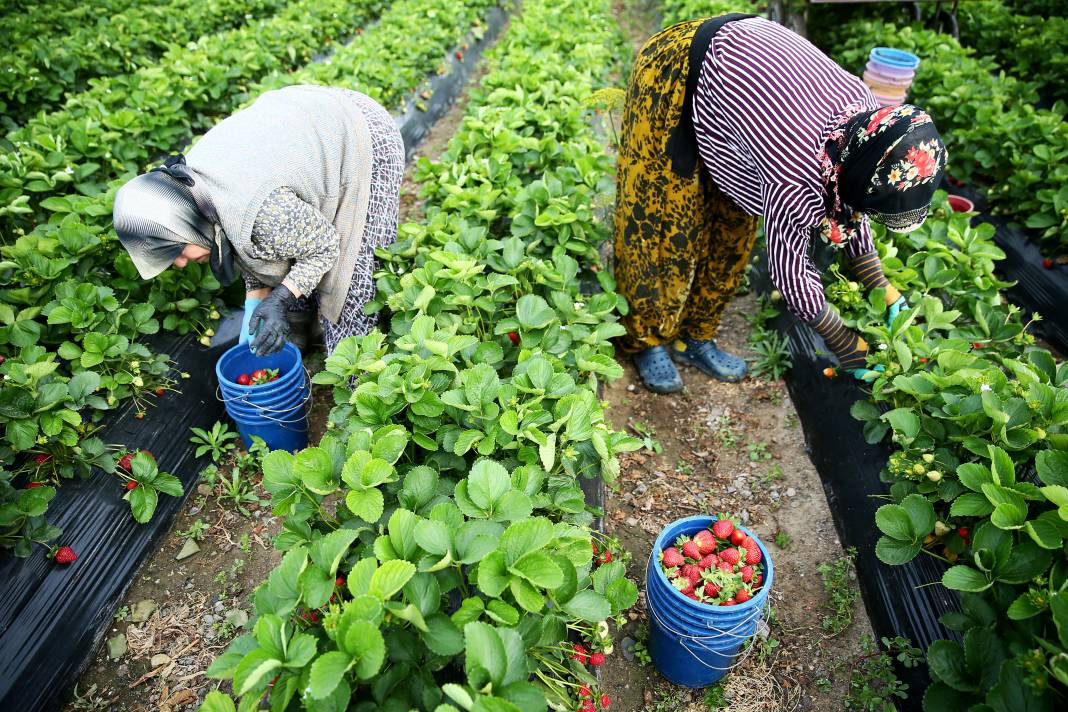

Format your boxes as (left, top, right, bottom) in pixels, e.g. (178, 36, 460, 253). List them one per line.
(202, 0, 640, 712)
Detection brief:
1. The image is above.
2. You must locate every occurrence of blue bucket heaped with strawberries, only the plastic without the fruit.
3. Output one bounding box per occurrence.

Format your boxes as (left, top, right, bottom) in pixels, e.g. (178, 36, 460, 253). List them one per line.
(645, 517, 774, 687)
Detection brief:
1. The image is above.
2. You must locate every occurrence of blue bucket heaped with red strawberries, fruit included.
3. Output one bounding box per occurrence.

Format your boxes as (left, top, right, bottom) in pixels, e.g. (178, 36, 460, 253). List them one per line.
(645, 515, 774, 687)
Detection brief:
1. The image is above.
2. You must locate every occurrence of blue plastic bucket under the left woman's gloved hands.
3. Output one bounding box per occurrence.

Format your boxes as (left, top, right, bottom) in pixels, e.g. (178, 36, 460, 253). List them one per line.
(215, 343, 311, 452)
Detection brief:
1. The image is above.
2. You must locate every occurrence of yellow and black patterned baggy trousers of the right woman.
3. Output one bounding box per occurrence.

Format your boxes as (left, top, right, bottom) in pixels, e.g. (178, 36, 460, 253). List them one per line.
(615, 20, 756, 352)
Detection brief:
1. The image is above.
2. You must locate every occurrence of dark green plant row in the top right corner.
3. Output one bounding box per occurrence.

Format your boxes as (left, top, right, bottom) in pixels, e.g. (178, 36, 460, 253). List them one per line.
(957, 0, 1068, 101)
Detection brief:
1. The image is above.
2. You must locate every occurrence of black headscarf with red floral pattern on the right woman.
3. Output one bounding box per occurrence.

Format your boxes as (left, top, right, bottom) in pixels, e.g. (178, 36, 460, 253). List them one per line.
(819, 104, 947, 247)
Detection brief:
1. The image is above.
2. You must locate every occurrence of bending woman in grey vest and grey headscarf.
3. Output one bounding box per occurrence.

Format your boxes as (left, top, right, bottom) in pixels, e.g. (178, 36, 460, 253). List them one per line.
(113, 86, 404, 355)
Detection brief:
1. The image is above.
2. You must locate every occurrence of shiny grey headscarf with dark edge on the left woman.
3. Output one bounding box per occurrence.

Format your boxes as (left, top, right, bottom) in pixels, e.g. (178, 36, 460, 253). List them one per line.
(112, 160, 235, 284)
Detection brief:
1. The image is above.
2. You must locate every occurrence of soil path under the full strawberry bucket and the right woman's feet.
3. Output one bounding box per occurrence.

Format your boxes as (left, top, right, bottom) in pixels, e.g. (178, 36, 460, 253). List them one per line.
(601, 0, 871, 712)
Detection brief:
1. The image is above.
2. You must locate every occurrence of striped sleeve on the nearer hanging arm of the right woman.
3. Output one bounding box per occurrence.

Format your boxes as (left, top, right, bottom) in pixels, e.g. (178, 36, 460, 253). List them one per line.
(764, 185, 827, 321)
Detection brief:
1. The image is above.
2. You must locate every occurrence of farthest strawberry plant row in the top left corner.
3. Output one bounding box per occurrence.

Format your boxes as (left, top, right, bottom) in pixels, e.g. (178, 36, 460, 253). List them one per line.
(0, 0, 286, 129)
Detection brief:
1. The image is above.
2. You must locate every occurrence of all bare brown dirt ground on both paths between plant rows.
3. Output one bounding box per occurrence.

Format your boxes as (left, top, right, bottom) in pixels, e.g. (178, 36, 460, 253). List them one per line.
(65, 5, 870, 712)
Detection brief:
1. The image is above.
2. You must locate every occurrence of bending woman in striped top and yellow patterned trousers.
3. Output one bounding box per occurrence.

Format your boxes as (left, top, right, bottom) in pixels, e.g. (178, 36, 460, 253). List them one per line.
(615, 14, 946, 393)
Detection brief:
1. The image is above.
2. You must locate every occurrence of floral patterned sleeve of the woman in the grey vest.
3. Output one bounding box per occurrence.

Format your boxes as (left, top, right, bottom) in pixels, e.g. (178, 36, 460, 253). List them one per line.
(246, 186, 341, 295)
